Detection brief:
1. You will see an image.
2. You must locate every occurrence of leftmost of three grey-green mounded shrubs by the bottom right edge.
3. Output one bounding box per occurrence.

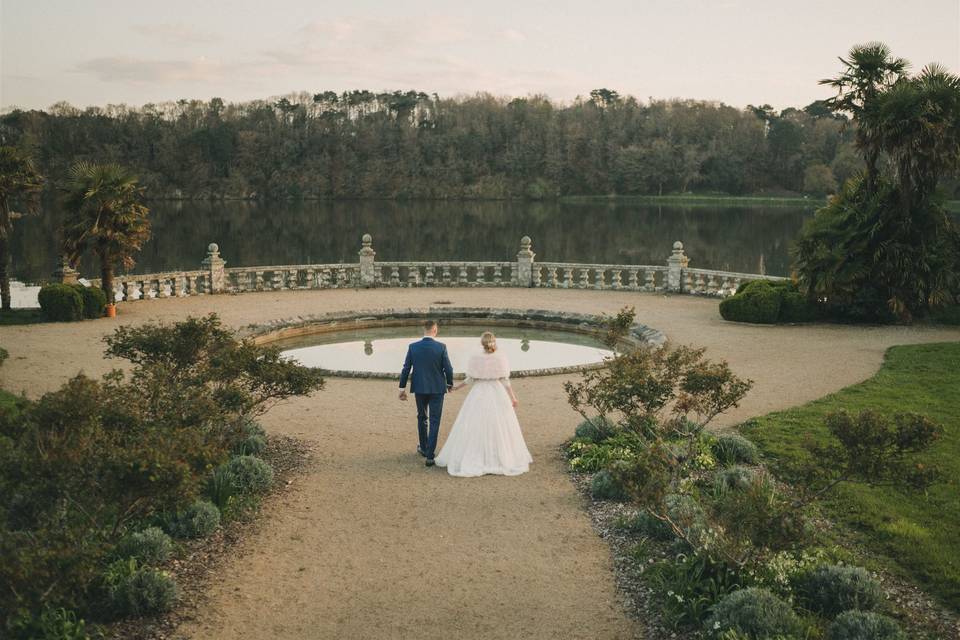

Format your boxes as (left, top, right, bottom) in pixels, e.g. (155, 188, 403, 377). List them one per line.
(705, 587, 800, 640)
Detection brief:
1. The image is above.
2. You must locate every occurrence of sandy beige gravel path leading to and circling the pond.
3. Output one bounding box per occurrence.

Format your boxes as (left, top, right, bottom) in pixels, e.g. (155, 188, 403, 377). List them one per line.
(0, 289, 960, 640)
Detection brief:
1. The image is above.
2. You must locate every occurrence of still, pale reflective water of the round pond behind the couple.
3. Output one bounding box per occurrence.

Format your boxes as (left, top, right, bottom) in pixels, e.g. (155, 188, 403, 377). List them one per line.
(279, 324, 613, 377)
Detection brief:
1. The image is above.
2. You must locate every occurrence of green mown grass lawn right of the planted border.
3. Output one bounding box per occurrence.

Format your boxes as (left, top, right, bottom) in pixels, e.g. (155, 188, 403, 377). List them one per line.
(741, 343, 960, 610)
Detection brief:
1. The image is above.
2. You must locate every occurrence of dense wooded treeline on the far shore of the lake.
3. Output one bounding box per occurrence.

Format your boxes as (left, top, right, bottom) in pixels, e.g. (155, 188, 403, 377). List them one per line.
(0, 89, 952, 199)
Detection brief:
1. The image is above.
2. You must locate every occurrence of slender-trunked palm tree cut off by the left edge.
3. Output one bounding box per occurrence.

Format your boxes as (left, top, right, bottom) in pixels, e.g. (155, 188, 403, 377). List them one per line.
(0, 147, 43, 311)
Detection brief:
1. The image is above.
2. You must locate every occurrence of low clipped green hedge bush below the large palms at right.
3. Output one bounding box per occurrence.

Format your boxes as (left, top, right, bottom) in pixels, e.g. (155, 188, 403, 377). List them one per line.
(720, 280, 817, 324)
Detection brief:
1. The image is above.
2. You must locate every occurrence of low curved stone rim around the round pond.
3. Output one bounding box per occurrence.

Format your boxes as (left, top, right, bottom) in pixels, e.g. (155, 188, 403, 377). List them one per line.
(246, 306, 666, 380)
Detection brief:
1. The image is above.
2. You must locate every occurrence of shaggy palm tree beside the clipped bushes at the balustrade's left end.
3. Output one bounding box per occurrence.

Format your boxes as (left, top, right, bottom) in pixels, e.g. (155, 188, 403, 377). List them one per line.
(63, 162, 150, 304)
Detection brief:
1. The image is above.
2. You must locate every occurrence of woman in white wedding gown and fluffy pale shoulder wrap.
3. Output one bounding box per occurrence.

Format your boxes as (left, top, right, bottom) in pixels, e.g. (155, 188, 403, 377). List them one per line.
(436, 331, 533, 477)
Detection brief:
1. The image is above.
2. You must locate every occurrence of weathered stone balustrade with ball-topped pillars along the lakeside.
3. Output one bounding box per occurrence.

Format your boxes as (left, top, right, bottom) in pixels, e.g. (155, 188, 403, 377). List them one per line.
(79, 234, 785, 302)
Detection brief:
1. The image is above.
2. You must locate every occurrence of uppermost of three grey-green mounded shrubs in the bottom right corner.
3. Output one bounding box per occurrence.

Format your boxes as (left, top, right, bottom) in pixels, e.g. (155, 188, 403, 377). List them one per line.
(797, 565, 883, 618)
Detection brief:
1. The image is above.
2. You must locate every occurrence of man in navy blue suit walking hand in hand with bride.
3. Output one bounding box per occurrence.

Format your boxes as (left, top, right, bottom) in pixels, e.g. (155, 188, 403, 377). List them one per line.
(400, 320, 453, 467)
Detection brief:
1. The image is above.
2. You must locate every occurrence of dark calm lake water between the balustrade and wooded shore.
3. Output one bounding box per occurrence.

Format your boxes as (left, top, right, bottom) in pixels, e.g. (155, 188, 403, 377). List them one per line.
(12, 200, 814, 282)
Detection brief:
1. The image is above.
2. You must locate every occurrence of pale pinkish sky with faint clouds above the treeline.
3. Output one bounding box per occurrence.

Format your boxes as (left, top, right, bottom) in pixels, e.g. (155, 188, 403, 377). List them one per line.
(0, 0, 960, 109)
